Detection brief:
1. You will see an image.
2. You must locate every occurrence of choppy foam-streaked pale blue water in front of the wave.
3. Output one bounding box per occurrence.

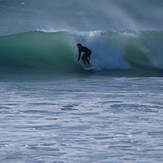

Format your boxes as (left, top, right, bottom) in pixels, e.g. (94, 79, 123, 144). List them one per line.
(0, 77, 163, 163)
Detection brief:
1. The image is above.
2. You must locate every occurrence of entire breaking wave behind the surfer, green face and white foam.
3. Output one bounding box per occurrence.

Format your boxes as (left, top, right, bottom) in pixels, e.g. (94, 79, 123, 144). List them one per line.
(0, 30, 163, 73)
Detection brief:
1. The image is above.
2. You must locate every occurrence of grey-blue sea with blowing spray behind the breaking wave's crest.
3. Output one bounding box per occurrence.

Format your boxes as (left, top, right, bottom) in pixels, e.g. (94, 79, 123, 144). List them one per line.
(0, 0, 163, 36)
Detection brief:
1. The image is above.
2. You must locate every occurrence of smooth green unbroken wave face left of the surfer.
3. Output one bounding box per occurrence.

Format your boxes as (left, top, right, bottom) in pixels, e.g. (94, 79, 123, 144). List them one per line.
(0, 31, 74, 71)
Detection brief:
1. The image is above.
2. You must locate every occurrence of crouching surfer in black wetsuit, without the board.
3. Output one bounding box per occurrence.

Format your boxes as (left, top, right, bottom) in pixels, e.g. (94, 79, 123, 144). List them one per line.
(76, 44, 92, 65)
